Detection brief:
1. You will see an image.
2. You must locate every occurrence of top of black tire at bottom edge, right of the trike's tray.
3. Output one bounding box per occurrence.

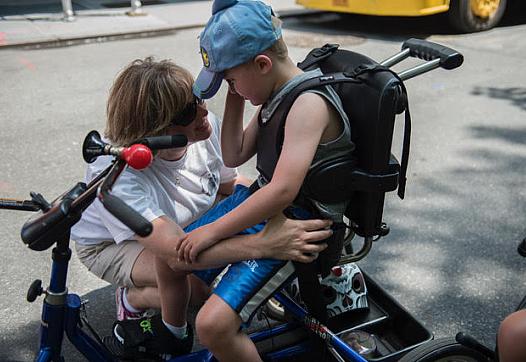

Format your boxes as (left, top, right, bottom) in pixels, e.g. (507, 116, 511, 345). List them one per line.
(399, 337, 496, 362)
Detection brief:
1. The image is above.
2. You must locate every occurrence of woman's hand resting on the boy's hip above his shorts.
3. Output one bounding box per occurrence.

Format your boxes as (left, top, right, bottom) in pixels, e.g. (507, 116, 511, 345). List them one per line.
(257, 213, 332, 263)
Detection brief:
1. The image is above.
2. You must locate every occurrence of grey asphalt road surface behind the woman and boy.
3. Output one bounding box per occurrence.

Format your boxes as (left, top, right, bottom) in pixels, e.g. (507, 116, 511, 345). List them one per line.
(0, 6, 526, 361)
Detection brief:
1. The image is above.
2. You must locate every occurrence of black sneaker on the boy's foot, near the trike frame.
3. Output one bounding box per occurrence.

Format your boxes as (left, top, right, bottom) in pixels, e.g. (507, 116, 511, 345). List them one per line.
(113, 314, 194, 360)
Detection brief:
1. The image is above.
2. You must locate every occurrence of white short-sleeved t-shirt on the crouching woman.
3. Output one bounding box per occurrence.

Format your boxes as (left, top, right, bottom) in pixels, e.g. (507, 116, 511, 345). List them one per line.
(71, 113, 237, 245)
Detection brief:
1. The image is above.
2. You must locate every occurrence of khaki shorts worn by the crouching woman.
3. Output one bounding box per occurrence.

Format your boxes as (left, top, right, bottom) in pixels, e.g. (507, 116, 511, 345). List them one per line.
(75, 240, 144, 288)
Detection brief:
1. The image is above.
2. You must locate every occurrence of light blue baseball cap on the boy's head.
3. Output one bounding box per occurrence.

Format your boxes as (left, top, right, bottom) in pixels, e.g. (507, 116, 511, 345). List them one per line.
(193, 0, 281, 99)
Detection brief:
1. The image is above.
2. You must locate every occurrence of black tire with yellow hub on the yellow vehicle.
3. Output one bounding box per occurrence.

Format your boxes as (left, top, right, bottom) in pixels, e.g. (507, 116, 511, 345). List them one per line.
(448, 0, 507, 33)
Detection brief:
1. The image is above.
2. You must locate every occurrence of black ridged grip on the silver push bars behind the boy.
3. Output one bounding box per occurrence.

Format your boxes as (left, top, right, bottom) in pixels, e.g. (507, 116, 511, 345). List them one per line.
(402, 38, 464, 70)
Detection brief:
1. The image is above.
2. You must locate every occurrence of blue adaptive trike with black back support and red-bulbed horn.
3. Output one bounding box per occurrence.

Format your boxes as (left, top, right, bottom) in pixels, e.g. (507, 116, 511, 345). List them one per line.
(0, 39, 489, 362)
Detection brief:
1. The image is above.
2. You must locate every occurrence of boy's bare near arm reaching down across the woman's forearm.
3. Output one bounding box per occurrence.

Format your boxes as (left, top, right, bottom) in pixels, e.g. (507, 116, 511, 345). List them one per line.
(180, 93, 329, 261)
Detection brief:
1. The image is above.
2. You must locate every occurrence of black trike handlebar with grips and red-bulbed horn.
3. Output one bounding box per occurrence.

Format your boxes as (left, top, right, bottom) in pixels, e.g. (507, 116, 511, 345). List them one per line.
(14, 131, 187, 251)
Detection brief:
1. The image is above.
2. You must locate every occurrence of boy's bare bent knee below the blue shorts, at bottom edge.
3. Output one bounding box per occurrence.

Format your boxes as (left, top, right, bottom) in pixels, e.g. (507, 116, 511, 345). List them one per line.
(196, 295, 261, 362)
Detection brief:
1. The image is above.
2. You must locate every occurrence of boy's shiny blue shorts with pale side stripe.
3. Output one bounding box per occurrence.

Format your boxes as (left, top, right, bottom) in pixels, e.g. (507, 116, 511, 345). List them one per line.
(184, 185, 294, 323)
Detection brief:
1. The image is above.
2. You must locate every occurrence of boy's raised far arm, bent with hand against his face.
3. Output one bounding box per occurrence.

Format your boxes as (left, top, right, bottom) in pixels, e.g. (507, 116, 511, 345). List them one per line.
(221, 91, 258, 167)
